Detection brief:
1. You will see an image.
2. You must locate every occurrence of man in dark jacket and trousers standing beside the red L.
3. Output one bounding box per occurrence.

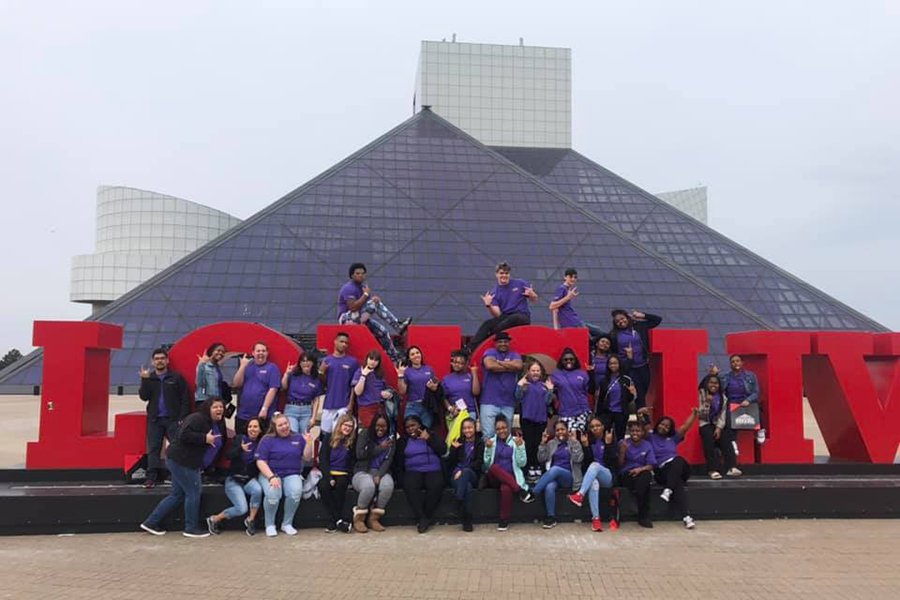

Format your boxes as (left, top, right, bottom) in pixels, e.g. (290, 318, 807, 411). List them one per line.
(138, 348, 191, 488)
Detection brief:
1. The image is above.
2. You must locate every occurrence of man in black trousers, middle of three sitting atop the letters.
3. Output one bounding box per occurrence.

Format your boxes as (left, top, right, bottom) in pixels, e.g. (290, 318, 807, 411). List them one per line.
(467, 262, 538, 354)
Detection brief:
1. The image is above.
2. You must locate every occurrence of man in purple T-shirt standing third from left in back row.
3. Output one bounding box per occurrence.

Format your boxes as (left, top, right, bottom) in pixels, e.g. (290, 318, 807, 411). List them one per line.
(232, 342, 281, 435)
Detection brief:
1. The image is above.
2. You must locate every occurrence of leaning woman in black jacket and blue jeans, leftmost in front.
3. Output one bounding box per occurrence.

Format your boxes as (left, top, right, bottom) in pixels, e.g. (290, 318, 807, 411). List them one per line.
(141, 398, 225, 538)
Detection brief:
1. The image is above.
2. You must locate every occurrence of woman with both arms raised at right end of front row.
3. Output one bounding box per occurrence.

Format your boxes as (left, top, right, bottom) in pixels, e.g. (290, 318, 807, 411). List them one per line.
(641, 407, 699, 529)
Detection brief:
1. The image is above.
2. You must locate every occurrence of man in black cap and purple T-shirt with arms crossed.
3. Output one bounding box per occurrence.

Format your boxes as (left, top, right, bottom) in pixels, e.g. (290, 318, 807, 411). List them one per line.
(478, 331, 522, 438)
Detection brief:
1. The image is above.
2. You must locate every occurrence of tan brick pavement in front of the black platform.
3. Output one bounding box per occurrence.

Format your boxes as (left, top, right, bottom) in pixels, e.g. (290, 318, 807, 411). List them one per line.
(0, 520, 900, 600)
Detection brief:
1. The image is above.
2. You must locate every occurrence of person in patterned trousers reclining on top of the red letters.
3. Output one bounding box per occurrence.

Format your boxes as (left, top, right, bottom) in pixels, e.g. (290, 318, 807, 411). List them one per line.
(338, 263, 412, 362)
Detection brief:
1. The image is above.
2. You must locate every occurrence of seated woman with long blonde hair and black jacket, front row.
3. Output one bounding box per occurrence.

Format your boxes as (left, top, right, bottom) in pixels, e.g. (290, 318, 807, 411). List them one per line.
(319, 415, 356, 533)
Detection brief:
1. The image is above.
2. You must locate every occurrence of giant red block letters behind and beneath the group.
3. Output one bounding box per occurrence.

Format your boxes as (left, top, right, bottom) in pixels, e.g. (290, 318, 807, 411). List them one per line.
(26, 321, 900, 469)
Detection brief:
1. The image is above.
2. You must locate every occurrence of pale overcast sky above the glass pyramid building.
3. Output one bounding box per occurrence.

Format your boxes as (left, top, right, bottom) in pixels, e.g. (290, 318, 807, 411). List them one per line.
(0, 0, 900, 352)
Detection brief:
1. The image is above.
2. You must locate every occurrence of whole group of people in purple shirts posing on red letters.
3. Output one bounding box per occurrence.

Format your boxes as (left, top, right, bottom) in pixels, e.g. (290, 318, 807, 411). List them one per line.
(139, 263, 759, 537)
